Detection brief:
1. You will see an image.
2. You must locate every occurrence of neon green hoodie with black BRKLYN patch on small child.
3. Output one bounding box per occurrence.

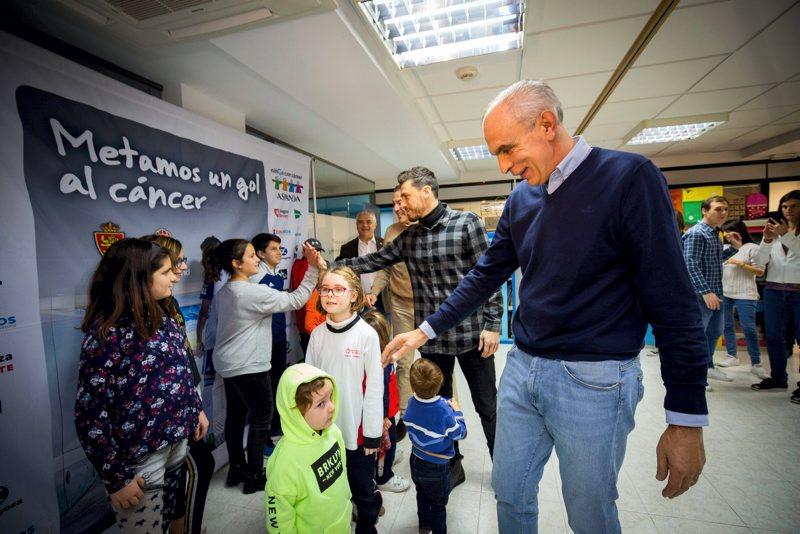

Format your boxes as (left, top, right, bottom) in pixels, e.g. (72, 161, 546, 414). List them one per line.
(264, 363, 352, 534)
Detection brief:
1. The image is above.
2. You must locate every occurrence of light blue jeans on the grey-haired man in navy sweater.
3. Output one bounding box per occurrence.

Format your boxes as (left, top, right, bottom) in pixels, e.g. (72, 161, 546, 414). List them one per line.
(492, 347, 644, 534)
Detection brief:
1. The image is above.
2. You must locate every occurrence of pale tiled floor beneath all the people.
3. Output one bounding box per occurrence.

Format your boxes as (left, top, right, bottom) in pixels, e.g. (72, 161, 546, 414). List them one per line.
(205, 346, 800, 534)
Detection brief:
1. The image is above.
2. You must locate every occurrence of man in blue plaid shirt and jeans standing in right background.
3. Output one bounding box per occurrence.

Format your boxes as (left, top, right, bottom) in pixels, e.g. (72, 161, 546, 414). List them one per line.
(681, 196, 736, 391)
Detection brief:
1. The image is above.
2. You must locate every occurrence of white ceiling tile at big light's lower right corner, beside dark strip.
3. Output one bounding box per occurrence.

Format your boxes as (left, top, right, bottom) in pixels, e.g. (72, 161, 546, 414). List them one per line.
(522, 17, 648, 79)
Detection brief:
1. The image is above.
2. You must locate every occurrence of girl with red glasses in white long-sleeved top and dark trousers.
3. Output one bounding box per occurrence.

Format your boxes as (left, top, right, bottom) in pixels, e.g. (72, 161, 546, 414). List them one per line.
(306, 267, 384, 534)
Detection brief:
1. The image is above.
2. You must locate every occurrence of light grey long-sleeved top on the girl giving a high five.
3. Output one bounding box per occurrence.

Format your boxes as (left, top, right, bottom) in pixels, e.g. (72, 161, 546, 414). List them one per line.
(214, 266, 318, 378)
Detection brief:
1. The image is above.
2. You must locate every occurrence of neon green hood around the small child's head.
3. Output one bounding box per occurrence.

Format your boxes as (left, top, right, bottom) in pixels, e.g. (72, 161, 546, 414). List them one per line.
(275, 363, 339, 443)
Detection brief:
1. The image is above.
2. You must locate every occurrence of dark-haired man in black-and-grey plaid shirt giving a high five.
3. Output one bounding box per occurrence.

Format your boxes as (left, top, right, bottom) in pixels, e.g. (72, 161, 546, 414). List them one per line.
(334, 167, 503, 485)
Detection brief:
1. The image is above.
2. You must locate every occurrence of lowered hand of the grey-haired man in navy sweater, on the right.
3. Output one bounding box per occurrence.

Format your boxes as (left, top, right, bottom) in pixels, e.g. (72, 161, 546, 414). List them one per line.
(656, 425, 706, 499)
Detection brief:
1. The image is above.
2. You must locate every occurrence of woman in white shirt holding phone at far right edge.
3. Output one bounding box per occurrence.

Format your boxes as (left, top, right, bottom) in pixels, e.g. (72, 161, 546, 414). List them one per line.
(751, 189, 800, 404)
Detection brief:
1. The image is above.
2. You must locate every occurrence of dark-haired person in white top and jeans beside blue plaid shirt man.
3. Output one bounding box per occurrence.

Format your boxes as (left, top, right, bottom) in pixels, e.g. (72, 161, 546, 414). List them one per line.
(718, 219, 767, 379)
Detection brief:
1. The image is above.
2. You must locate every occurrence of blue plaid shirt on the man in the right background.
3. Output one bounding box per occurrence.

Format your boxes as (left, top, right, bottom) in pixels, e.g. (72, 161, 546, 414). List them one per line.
(681, 221, 736, 298)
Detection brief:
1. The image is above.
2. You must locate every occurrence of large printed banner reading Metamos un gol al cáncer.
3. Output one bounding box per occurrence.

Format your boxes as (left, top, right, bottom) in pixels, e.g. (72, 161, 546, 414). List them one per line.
(0, 33, 309, 533)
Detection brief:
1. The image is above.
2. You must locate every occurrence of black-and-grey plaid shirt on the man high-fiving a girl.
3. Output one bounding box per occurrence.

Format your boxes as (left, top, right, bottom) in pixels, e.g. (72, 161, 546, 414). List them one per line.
(333, 204, 503, 354)
